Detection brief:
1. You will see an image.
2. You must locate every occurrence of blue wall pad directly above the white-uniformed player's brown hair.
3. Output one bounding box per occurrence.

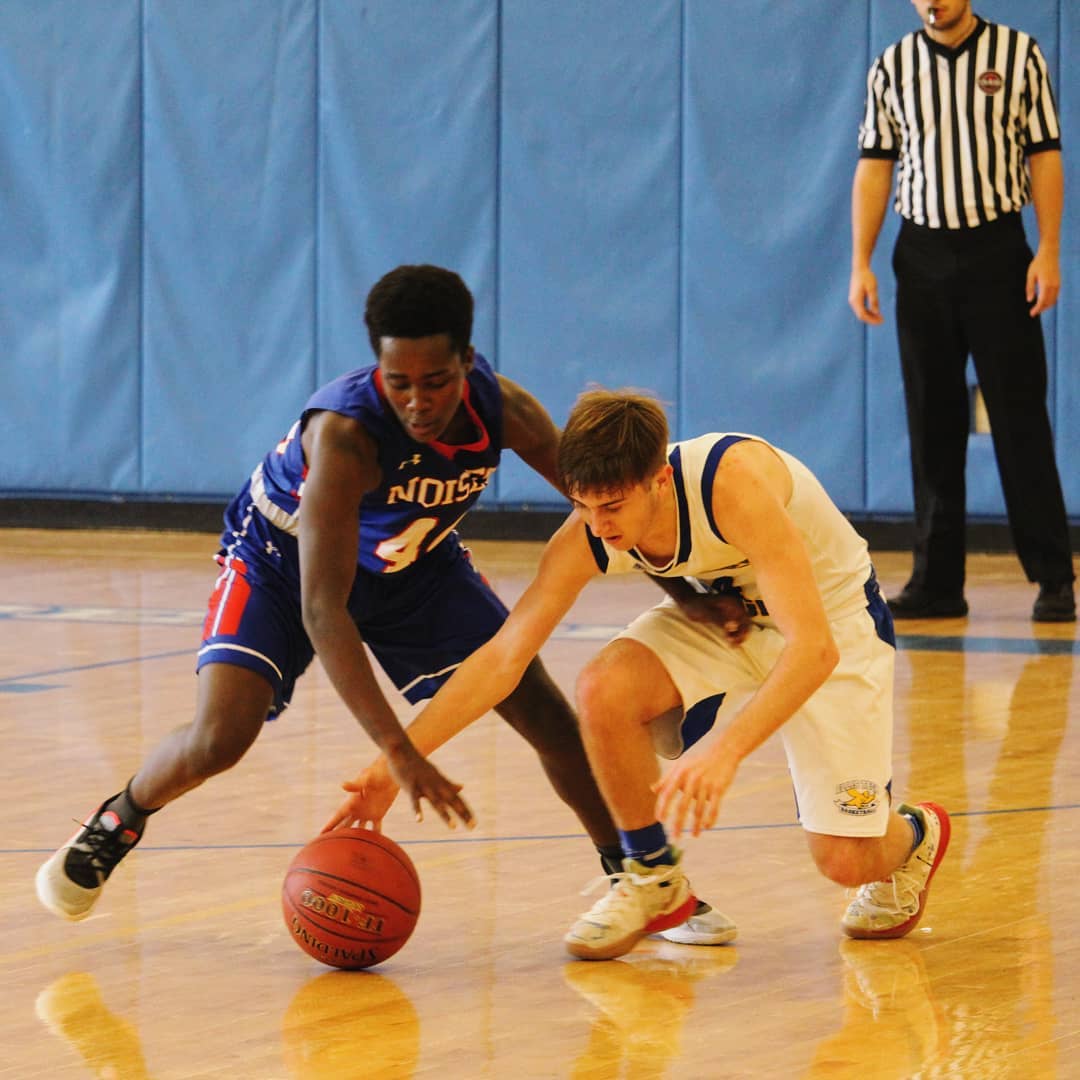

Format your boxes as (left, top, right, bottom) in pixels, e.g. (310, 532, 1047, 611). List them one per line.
(499, 0, 680, 502)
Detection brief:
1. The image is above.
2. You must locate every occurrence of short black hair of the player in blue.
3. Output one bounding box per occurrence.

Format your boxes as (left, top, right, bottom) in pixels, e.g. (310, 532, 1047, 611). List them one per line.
(364, 264, 473, 356)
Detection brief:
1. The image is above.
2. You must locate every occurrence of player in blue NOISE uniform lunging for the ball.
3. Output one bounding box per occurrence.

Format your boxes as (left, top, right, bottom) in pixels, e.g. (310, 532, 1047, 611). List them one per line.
(37, 266, 734, 944)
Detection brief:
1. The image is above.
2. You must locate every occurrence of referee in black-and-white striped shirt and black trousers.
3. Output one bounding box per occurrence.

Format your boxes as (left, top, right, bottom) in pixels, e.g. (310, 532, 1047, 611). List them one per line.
(848, 0, 1076, 622)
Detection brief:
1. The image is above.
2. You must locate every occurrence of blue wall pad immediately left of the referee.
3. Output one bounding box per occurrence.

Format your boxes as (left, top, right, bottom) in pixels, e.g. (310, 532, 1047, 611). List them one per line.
(680, 0, 866, 507)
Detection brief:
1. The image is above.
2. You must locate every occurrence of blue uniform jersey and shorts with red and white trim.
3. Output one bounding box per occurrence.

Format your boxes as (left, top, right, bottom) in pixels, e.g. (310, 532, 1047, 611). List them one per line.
(198, 356, 507, 715)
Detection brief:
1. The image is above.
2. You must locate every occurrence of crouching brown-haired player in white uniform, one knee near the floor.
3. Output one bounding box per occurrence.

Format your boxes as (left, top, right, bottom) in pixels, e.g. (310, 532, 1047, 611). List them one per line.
(332, 390, 949, 959)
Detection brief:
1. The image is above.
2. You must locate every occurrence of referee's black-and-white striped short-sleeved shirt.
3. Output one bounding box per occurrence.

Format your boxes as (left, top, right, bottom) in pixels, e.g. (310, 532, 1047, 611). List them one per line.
(859, 18, 1061, 229)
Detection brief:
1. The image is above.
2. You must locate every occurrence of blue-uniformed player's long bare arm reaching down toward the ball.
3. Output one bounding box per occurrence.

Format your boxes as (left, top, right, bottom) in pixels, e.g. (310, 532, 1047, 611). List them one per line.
(299, 411, 471, 821)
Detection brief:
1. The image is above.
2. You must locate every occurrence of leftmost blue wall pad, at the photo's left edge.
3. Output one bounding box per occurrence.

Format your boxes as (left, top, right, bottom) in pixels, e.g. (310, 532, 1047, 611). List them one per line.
(0, 0, 141, 491)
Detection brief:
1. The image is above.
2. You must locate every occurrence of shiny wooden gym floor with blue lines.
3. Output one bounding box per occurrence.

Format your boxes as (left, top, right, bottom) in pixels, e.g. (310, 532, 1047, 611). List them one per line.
(0, 530, 1080, 1080)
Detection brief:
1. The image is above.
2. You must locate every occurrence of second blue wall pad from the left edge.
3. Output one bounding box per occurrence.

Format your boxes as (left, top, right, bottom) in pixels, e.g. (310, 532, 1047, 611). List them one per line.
(142, 0, 315, 495)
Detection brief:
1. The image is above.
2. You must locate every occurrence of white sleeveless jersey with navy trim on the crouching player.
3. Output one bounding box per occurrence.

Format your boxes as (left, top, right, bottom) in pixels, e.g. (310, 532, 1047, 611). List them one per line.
(588, 433, 872, 625)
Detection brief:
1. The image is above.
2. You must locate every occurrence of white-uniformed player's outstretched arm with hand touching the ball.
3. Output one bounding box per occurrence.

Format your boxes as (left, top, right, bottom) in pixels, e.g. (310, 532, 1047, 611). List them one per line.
(323, 514, 599, 832)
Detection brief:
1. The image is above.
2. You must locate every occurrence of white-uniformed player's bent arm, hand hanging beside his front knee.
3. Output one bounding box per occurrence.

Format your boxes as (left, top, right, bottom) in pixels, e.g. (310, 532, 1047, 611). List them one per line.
(657, 441, 839, 836)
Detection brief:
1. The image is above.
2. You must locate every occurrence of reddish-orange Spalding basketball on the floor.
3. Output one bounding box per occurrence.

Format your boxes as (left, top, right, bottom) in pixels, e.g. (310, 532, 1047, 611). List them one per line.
(281, 828, 420, 969)
